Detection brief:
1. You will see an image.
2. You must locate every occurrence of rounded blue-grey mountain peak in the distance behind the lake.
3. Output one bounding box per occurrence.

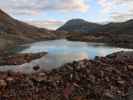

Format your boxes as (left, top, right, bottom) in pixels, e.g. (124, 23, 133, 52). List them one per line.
(57, 19, 100, 33)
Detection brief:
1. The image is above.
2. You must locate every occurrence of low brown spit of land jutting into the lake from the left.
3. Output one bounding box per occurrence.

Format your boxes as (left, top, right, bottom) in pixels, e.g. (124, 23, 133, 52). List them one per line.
(0, 52, 47, 66)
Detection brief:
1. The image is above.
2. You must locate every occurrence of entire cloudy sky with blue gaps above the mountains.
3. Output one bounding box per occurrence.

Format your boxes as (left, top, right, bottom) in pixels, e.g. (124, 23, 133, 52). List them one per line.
(0, 0, 133, 29)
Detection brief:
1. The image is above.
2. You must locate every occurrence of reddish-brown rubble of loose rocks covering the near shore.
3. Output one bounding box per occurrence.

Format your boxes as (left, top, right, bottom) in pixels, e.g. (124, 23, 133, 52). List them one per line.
(0, 52, 133, 100)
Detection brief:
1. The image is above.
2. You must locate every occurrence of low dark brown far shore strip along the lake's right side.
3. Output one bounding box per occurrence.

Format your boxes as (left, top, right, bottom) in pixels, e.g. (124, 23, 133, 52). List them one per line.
(66, 36, 133, 49)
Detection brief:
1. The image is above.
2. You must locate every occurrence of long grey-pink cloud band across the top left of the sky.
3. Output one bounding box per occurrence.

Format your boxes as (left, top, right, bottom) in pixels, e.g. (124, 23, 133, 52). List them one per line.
(0, 0, 88, 15)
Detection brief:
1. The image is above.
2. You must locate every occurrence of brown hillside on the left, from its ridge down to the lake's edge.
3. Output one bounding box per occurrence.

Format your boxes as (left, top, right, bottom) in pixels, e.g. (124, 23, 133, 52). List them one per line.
(0, 10, 56, 51)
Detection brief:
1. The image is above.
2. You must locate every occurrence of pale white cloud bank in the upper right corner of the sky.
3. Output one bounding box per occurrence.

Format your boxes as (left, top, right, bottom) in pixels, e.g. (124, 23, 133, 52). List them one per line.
(97, 0, 133, 21)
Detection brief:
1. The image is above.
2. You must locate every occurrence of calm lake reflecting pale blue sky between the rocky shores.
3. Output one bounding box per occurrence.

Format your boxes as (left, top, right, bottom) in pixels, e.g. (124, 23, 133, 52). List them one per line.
(0, 39, 132, 73)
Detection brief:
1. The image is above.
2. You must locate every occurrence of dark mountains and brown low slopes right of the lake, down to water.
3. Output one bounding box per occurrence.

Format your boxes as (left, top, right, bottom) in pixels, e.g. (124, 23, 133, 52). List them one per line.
(56, 19, 133, 48)
